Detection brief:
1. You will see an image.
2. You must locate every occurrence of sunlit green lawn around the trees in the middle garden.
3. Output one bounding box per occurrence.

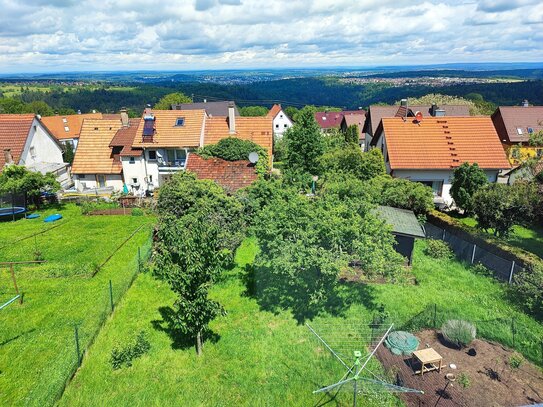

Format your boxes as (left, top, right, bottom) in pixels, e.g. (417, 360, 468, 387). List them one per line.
(60, 239, 543, 406)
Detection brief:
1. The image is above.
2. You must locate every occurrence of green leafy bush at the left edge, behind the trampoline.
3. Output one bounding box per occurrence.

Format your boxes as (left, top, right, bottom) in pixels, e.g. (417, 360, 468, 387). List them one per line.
(0, 165, 60, 207)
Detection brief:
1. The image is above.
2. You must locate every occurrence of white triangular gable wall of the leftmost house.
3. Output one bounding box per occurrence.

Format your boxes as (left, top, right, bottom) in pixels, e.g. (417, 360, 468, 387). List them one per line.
(19, 119, 64, 167)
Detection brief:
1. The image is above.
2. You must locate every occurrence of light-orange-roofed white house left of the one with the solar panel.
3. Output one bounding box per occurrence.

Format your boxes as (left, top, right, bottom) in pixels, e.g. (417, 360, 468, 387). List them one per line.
(72, 115, 124, 191)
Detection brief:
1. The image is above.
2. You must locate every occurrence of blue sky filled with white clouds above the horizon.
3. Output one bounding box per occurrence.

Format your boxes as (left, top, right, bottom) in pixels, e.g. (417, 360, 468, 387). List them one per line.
(0, 0, 543, 73)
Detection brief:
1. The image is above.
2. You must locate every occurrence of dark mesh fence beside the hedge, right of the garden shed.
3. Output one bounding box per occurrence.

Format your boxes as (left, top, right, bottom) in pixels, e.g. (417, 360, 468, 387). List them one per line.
(425, 223, 523, 284)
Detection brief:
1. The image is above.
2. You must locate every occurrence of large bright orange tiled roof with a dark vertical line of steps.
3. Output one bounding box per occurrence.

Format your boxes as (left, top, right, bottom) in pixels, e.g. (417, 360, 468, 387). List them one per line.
(382, 117, 510, 170)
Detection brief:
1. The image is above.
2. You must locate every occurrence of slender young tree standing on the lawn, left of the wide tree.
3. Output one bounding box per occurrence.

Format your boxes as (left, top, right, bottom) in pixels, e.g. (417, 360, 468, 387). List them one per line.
(155, 210, 231, 356)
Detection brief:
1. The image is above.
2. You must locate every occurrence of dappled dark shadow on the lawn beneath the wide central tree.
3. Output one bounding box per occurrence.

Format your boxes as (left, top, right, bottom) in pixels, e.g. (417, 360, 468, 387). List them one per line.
(242, 264, 378, 324)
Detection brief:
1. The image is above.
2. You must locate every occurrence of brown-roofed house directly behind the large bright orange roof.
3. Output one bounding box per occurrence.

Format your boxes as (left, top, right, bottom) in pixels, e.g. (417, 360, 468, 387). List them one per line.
(363, 99, 470, 150)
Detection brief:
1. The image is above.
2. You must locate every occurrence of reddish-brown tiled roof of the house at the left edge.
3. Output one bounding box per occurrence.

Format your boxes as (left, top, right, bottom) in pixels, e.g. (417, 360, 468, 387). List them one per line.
(0, 114, 35, 171)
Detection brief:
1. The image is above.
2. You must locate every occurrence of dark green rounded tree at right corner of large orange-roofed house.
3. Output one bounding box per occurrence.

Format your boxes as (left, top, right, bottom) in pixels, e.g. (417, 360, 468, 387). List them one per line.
(451, 163, 488, 215)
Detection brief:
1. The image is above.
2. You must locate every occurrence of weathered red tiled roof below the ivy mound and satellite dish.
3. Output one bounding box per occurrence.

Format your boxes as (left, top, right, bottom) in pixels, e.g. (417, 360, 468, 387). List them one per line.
(186, 153, 258, 192)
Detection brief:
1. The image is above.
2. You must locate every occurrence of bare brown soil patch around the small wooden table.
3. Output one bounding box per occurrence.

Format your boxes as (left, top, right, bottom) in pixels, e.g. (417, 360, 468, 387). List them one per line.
(377, 330, 543, 407)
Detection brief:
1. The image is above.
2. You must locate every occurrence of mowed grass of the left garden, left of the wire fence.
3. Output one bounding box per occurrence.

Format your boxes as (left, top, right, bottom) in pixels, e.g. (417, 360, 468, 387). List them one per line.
(0, 205, 153, 406)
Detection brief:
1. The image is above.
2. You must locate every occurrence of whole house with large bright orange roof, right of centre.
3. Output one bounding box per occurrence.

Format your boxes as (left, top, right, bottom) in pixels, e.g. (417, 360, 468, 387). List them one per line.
(370, 116, 510, 206)
